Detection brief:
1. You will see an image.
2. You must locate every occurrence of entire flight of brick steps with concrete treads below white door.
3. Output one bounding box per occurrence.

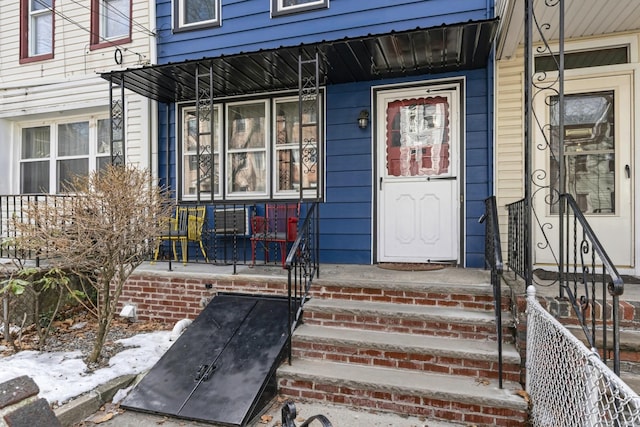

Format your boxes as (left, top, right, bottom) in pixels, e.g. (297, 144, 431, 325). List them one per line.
(277, 269, 527, 426)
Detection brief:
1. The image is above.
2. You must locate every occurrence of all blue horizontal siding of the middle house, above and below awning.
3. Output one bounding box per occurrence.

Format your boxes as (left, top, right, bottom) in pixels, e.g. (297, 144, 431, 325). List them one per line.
(157, 0, 493, 267)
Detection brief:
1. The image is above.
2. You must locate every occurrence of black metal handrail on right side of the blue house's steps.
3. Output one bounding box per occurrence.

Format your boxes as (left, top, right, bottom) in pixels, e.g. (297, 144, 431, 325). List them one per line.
(480, 196, 503, 388)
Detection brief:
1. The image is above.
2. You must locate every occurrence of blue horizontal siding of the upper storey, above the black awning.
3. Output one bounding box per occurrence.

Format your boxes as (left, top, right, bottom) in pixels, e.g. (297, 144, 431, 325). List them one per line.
(157, 0, 492, 63)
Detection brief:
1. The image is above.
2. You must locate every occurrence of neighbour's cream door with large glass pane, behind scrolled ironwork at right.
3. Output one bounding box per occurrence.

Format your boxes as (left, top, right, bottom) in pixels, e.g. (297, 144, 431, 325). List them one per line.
(533, 73, 635, 268)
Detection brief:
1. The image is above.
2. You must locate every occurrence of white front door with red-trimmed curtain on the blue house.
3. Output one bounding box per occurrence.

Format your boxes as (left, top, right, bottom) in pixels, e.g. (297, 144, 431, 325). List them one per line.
(375, 83, 461, 262)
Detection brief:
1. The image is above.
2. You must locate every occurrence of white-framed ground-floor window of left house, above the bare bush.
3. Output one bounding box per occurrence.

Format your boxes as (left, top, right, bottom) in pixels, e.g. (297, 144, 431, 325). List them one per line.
(20, 118, 111, 194)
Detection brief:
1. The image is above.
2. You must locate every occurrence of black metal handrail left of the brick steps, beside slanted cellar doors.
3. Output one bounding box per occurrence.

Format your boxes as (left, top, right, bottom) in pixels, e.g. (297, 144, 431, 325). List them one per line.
(285, 202, 320, 364)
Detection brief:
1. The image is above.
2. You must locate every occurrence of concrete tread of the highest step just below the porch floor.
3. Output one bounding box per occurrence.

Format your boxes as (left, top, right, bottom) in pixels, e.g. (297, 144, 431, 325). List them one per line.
(304, 298, 513, 327)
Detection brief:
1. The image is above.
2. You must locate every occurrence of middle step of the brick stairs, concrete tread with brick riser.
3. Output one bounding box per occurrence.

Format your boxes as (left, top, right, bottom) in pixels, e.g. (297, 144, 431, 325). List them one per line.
(293, 324, 520, 381)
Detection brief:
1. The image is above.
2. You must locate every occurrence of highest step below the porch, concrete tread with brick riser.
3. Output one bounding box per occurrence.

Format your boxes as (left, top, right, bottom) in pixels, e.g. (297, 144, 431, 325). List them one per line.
(304, 299, 512, 340)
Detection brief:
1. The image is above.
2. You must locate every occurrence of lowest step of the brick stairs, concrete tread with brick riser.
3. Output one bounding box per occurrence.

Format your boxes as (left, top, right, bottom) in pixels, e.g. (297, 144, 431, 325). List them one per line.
(278, 359, 527, 426)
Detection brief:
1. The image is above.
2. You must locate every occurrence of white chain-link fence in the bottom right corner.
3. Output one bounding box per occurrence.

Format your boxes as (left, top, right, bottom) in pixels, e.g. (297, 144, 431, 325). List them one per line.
(527, 286, 640, 426)
